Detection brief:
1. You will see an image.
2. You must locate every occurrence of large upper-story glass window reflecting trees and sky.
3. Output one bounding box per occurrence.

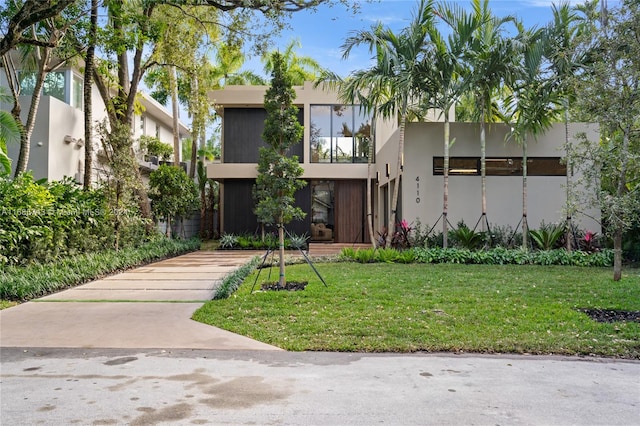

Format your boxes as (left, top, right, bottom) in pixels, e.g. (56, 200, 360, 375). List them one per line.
(310, 105, 373, 163)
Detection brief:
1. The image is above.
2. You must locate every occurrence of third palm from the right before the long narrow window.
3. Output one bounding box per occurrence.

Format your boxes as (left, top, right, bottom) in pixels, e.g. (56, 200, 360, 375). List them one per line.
(465, 0, 514, 231)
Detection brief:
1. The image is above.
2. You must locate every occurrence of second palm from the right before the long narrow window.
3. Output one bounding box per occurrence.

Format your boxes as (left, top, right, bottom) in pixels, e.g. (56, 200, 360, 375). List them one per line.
(509, 22, 559, 249)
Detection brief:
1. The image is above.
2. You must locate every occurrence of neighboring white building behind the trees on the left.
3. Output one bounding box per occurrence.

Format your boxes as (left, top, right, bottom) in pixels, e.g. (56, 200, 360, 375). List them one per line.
(0, 55, 189, 182)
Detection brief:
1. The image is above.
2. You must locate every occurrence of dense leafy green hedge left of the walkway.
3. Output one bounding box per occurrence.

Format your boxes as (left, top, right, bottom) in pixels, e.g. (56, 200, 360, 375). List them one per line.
(0, 173, 147, 265)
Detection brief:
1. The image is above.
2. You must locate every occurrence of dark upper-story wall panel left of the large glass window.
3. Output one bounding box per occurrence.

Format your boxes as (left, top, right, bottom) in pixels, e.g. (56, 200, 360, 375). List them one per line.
(223, 108, 304, 163)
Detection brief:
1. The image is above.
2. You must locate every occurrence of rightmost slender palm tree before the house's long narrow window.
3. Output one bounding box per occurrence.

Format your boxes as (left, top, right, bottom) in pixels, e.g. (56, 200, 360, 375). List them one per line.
(545, 3, 586, 251)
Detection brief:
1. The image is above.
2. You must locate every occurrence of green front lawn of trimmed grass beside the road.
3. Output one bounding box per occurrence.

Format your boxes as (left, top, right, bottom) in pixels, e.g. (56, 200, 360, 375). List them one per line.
(194, 263, 640, 359)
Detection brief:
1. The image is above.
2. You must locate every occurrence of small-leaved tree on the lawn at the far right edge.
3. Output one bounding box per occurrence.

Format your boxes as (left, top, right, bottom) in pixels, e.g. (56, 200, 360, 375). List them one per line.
(575, 0, 640, 281)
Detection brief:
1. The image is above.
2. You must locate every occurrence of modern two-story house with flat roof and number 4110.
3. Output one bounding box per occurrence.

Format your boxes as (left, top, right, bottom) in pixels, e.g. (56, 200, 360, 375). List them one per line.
(207, 83, 600, 243)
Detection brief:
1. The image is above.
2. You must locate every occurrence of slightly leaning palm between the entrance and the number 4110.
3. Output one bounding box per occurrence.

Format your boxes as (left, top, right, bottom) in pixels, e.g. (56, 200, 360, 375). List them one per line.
(340, 0, 434, 242)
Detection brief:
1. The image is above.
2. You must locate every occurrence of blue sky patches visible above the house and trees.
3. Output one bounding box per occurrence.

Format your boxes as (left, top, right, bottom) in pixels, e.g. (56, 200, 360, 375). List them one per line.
(243, 0, 619, 77)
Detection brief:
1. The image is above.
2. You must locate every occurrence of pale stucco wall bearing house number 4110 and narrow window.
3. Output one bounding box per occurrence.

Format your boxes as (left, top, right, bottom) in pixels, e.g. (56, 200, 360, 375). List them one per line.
(376, 123, 600, 232)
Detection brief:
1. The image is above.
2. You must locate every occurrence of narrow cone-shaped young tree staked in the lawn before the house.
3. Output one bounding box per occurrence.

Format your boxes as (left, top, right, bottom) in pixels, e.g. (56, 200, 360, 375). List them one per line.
(254, 53, 306, 288)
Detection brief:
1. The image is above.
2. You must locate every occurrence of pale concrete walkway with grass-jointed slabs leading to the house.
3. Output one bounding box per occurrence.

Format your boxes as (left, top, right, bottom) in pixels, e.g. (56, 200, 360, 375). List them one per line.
(0, 251, 280, 350)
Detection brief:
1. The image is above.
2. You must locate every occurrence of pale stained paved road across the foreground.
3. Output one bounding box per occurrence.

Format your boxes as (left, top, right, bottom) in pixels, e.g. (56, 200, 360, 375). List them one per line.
(0, 348, 640, 425)
